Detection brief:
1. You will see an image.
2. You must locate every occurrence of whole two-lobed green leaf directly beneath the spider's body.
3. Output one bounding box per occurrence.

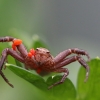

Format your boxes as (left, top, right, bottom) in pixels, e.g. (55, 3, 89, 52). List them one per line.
(6, 63, 76, 100)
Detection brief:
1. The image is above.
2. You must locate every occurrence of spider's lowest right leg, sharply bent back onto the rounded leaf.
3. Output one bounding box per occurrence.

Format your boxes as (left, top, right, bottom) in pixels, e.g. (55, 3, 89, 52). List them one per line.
(48, 68, 69, 89)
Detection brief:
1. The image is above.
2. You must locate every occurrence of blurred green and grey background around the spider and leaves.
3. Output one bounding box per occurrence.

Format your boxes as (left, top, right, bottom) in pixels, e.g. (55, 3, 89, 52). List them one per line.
(0, 0, 100, 100)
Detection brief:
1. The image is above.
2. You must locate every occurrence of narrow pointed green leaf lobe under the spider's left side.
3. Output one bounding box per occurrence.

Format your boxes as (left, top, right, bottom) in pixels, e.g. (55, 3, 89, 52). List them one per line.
(6, 64, 47, 90)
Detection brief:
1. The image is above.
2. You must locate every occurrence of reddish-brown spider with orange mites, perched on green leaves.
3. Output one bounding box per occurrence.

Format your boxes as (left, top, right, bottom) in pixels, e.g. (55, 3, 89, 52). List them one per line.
(0, 36, 90, 89)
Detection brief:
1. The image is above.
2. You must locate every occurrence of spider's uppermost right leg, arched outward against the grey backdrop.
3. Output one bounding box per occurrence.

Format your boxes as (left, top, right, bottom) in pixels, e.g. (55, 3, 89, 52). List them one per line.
(54, 48, 90, 64)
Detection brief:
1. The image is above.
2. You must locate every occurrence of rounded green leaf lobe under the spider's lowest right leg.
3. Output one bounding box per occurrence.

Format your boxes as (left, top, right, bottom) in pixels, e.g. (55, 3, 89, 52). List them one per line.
(47, 76, 76, 100)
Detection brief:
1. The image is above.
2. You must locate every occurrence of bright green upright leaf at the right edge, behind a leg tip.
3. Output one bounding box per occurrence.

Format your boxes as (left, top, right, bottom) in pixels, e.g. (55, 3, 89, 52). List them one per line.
(77, 58, 100, 100)
